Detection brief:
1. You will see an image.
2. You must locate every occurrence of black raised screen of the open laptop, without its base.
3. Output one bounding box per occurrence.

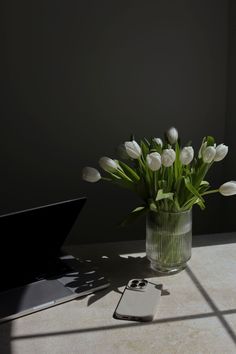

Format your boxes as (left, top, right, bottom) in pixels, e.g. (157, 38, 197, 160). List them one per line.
(0, 198, 86, 279)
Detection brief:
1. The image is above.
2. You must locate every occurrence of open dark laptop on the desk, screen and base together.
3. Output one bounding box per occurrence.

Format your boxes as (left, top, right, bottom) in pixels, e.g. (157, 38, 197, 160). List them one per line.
(0, 197, 109, 322)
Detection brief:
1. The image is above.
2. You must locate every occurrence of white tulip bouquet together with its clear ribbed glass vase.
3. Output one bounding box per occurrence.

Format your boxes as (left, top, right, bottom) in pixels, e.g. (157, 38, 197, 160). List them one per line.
(82, 127, 236, 272)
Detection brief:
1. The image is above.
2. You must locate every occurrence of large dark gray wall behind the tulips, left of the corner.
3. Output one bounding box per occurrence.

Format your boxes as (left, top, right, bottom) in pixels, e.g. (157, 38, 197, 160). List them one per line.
(0, 0, 230, 243)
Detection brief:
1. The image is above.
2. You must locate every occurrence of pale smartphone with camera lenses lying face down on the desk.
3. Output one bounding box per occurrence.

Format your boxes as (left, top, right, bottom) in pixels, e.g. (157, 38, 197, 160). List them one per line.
(114, 279, 162, 321)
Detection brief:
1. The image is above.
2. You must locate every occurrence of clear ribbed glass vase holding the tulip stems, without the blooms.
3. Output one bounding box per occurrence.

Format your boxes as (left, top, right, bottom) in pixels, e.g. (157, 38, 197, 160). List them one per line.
(146, 210, 192, 274)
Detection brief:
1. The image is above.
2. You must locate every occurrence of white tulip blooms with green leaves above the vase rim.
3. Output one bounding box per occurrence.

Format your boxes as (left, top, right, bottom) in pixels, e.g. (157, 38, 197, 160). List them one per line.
(82, 127, 236, 224)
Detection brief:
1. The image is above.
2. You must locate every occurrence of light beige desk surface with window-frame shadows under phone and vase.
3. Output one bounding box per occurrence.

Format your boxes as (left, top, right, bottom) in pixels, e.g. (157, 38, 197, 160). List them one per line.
(0, 233, 236, 354)
